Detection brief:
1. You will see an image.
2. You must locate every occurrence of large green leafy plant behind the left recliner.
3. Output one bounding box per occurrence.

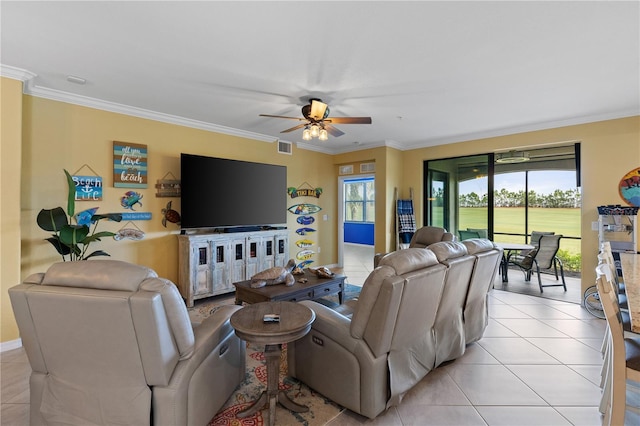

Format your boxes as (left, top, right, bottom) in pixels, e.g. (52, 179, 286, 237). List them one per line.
(36, 170, 122, 261)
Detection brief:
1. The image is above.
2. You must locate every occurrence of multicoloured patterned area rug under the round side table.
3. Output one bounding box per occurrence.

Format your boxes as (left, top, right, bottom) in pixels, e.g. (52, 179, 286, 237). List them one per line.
(188, 284, 361, 426)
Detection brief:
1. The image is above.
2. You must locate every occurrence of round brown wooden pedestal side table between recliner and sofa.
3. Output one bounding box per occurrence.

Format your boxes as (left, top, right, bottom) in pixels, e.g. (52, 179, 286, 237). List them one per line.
(230, 302, 316, 425)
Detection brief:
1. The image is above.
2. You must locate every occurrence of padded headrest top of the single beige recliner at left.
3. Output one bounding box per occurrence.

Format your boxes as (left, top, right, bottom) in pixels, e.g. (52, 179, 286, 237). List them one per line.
(42, 260, 158, 291)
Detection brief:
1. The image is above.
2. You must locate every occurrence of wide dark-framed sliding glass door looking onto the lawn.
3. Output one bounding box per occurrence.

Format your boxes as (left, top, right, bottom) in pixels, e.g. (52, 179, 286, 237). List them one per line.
(423, 144, 581, 272)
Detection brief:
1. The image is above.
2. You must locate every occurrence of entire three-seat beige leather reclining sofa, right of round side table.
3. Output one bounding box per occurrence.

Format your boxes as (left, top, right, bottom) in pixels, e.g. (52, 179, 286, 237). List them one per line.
(287, 240, 501, 418)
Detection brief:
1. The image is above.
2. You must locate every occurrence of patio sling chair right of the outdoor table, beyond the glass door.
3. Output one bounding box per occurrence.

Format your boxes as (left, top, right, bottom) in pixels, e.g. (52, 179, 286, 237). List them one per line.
(508, 235, 567, 293)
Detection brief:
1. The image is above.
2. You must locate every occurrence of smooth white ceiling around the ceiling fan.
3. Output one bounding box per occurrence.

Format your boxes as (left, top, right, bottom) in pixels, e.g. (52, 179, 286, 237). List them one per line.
(0, 1, 640, 153)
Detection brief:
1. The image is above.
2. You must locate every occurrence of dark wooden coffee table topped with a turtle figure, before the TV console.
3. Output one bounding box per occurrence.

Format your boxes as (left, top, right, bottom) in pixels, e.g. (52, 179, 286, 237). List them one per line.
(233, 269, 347, 305)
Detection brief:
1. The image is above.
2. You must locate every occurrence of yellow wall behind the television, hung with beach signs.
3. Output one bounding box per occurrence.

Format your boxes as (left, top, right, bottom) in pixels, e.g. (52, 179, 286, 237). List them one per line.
(1, 79, 337, 341)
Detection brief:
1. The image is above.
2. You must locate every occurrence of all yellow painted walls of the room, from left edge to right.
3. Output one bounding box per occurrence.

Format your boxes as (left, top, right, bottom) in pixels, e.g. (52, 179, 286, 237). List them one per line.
(0, 72, 640, 342)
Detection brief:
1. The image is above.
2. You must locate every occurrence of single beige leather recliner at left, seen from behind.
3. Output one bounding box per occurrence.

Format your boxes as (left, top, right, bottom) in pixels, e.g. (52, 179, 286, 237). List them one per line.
(9, 260, 246, 426)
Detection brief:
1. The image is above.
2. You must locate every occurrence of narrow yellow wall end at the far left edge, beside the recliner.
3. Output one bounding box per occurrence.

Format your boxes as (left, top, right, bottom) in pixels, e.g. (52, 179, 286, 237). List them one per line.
(0, 79, 22, 342)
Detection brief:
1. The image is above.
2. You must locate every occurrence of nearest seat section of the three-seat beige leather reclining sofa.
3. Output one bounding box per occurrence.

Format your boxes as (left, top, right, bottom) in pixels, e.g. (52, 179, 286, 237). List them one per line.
(287, 248, 446, 418)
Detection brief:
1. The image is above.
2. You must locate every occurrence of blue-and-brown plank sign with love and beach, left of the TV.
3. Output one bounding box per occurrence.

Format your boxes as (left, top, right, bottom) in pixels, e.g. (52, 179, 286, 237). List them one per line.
(113, 141, 147, 188)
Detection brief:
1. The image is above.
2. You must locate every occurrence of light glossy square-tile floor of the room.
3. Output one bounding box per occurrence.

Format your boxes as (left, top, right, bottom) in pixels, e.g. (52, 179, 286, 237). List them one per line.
(0, 245, 640, 426)
